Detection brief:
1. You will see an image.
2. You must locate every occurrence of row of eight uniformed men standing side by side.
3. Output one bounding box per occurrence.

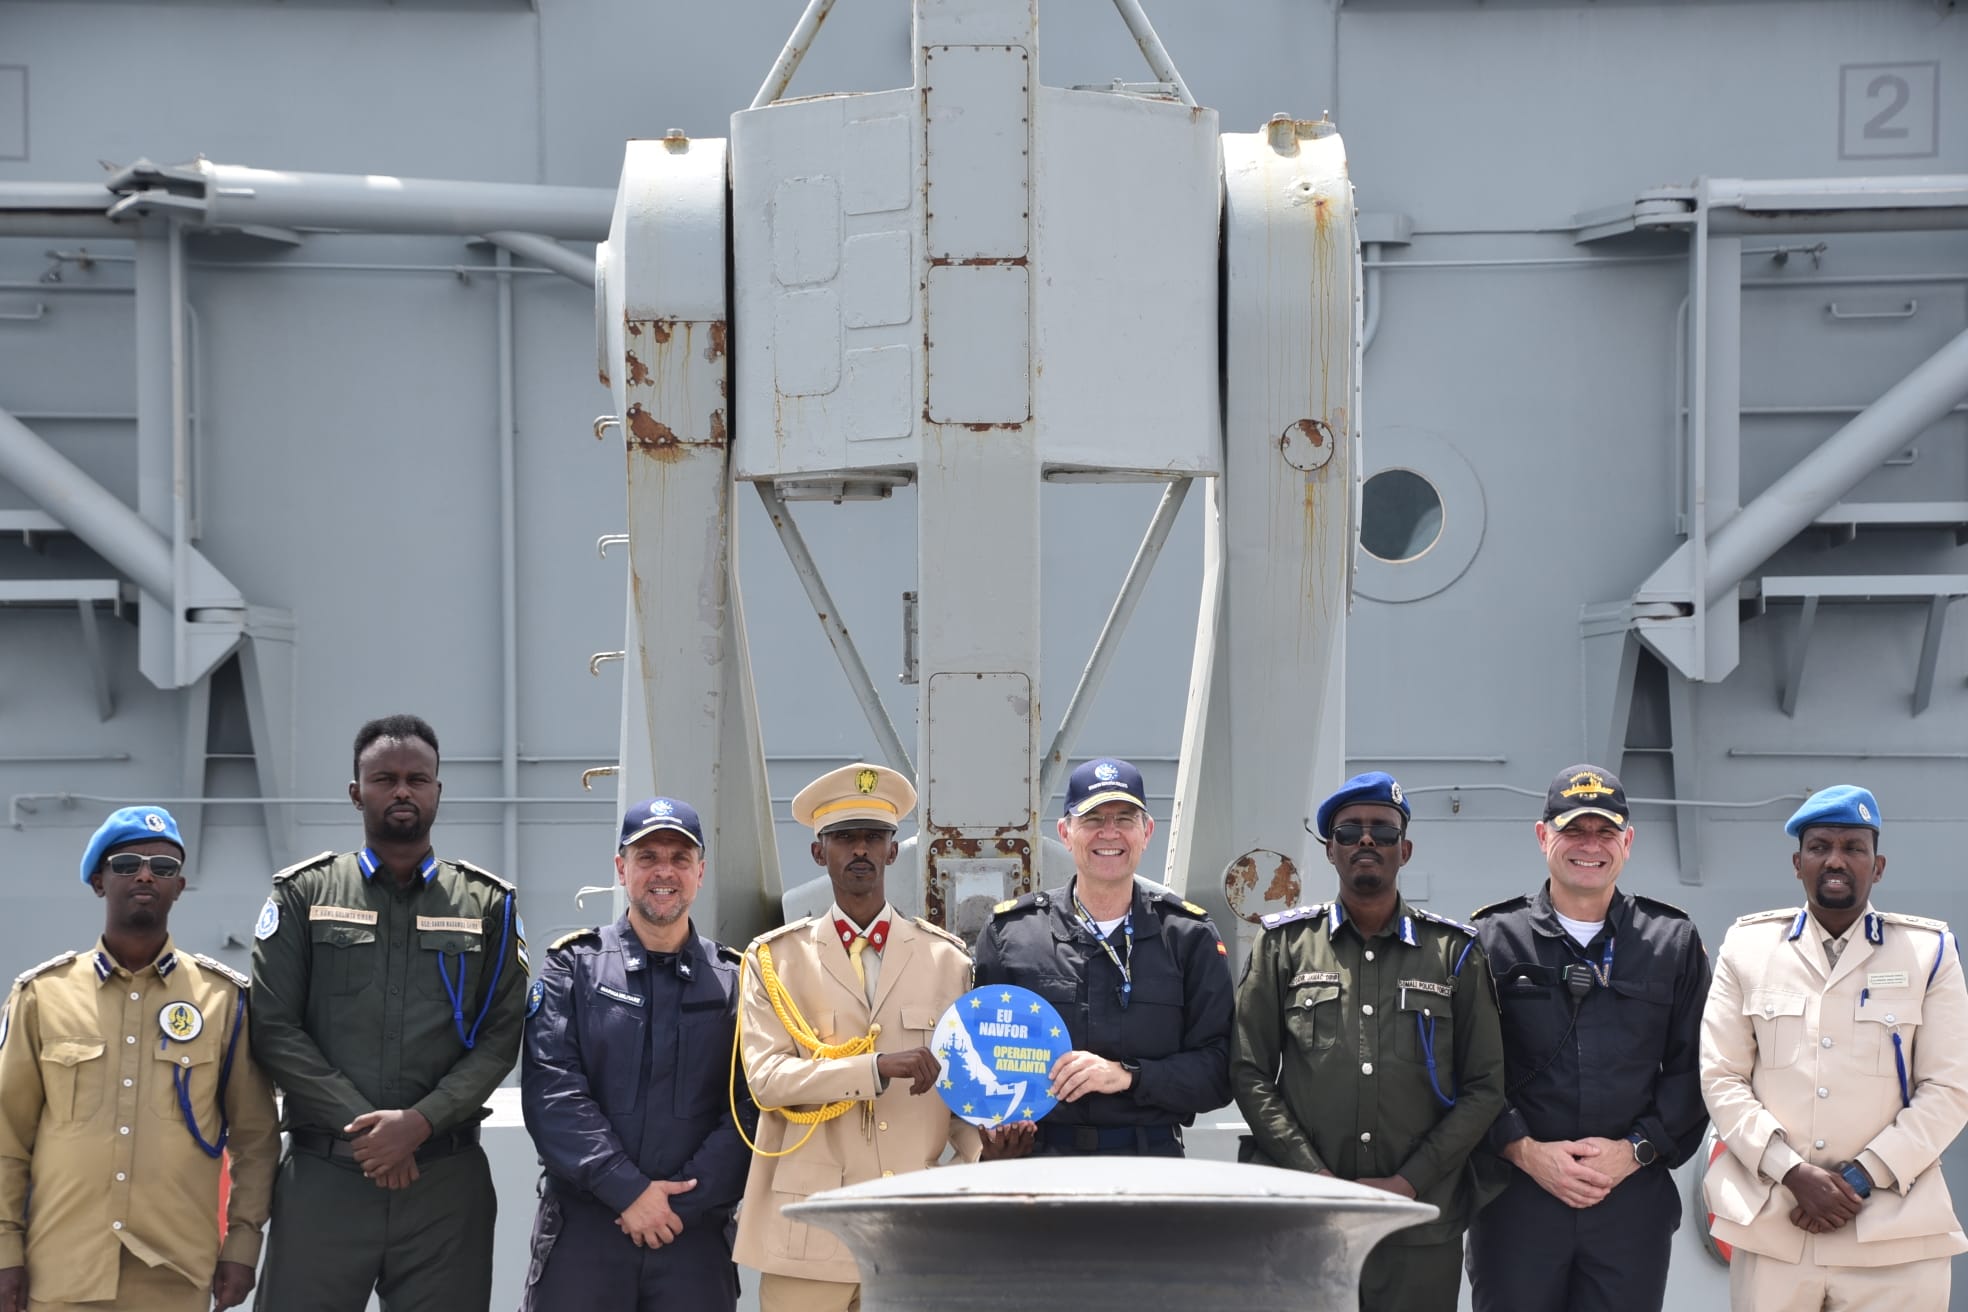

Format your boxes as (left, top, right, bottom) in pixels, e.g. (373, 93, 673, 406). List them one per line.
(0, 716, 1968, 1312)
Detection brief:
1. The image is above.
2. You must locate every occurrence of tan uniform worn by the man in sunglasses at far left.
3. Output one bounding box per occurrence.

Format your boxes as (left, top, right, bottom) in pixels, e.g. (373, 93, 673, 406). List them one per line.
(0, 940, 279, 1312)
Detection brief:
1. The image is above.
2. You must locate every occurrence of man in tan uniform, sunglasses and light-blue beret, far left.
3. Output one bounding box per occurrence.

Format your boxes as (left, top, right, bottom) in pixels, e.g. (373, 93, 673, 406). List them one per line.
(0, 806, 279, 1312)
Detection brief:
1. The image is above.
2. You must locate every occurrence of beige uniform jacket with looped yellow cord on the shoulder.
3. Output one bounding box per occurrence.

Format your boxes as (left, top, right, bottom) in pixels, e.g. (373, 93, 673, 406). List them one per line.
(732, 915, 980, 1282)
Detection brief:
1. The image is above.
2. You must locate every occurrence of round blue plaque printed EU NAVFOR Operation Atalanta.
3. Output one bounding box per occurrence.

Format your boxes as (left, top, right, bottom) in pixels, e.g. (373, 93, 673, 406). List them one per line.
(929, 984, 1073, 1127)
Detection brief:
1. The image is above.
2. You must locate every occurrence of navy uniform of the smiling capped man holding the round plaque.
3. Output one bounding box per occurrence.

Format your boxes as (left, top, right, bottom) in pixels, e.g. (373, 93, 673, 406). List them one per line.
(976, 881, 1236, 1157)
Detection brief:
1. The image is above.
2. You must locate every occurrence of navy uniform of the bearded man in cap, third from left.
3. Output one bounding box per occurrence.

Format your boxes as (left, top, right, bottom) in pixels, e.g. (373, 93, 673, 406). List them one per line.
(520, 915, 758, 1312)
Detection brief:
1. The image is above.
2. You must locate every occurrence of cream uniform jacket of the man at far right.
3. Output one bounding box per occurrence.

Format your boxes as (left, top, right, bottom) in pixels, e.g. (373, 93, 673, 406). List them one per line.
(1702, 907, 1968, 1267)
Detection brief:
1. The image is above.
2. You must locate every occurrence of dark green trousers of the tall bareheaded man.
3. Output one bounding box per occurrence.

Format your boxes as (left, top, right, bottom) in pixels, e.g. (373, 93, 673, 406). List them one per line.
(254, 1145, 498, 1312)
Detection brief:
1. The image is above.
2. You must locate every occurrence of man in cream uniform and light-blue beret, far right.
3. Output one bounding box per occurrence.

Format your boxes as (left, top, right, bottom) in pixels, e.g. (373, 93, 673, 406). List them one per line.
(1702, 783, 1968, 1312)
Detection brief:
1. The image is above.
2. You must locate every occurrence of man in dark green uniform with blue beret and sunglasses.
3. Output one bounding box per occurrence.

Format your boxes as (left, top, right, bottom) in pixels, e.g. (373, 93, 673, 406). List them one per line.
(1230, 771, 1504, 1312)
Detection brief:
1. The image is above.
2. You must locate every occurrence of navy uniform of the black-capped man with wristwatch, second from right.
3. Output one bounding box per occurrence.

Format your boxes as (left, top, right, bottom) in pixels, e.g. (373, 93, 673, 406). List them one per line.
(1468, 885, 1708, 1312)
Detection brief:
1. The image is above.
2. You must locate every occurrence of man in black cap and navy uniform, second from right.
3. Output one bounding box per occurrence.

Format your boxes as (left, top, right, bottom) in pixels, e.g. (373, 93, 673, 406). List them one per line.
(1468, 765, 1708, 1312)
